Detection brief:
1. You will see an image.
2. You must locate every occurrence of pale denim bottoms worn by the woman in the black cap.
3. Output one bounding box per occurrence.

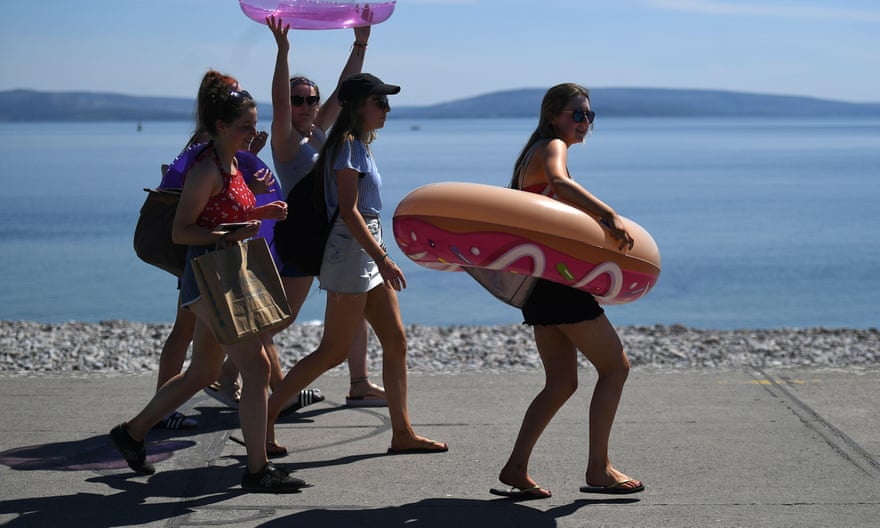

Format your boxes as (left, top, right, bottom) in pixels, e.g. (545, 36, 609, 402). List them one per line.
(319, 217, 384, 294)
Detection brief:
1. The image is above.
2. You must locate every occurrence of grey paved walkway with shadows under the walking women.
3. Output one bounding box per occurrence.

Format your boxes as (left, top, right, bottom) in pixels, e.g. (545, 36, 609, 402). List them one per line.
(0, 369, 880, 528)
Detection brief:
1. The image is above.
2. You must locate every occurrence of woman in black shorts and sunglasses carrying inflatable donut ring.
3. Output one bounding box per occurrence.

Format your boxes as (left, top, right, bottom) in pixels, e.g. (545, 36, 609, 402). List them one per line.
(491, 83, 645, 499)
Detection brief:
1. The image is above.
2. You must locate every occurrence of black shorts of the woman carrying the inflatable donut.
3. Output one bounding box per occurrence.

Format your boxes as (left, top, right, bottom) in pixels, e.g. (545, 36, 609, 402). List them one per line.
(522, 279, 605, 325)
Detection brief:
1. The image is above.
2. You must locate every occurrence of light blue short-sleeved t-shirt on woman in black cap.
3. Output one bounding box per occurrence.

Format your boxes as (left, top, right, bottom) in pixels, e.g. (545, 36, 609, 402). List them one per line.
(324, 140, 382, 218)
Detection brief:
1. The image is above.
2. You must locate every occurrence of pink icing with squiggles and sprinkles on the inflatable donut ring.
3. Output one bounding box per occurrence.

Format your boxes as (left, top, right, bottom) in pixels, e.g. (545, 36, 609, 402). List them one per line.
(394, 217, 657, 304)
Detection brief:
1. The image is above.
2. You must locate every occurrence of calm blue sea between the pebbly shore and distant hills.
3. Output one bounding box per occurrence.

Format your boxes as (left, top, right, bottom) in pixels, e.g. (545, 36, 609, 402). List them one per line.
(0, 116, 880, 329)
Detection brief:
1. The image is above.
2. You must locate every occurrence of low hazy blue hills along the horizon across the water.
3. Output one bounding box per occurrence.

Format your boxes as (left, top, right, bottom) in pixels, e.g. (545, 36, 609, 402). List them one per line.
(0, 88, 880, 122)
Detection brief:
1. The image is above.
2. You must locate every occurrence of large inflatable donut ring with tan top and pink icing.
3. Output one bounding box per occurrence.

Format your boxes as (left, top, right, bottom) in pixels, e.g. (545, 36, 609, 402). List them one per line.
(393, 183, 660, 304)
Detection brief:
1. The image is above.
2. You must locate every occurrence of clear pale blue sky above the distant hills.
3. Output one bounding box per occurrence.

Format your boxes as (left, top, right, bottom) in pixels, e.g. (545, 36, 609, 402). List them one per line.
(0, 0, 880, 105)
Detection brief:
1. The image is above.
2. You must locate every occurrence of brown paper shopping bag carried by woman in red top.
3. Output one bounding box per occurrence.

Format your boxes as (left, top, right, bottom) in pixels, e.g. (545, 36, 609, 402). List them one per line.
(192, 238, 291, 345)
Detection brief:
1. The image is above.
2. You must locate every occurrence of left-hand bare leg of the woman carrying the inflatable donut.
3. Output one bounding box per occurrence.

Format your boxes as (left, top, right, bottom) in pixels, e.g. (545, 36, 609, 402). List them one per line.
(498, 325, 578, 489)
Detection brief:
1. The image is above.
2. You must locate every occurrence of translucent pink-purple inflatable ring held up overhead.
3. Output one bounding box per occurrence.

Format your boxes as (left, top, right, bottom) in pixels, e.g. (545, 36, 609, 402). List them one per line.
(238, 0, 397, 29)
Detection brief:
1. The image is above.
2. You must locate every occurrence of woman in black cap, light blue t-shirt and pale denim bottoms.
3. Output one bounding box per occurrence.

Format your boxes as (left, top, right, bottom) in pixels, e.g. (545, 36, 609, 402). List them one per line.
(266, 73, 448, 453)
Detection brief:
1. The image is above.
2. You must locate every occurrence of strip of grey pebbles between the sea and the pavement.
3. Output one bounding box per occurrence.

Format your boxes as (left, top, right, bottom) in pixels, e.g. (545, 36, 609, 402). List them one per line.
(0, 321, 880, 375)
